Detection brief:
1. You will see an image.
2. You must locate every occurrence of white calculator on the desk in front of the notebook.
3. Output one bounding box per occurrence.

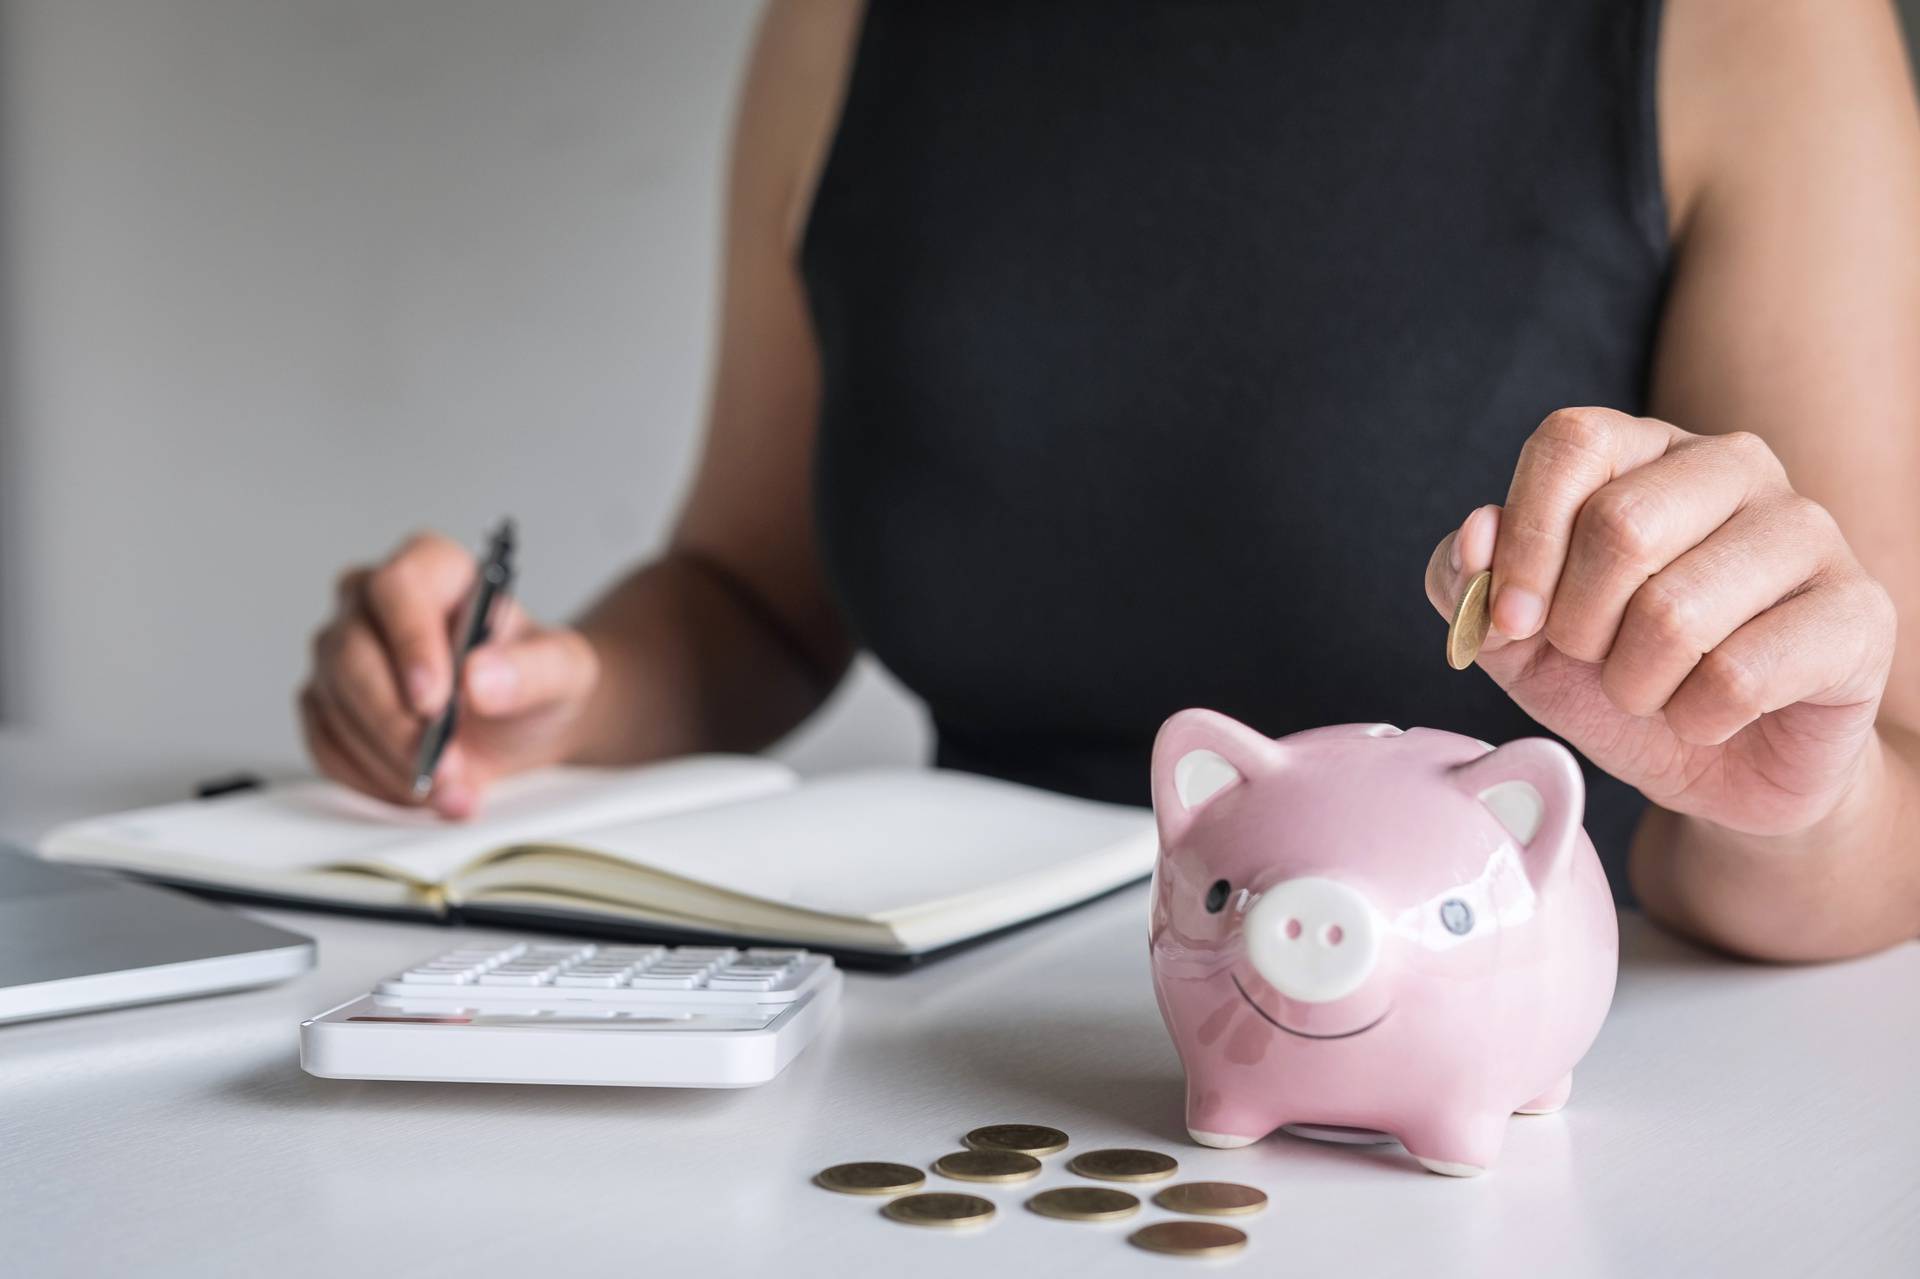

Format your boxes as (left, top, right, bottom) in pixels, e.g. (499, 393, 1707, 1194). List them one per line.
(300, 943, 841, 1089)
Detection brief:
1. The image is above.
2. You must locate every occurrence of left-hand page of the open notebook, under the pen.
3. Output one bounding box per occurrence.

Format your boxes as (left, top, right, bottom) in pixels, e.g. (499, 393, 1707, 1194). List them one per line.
(44, 755, 795, 883)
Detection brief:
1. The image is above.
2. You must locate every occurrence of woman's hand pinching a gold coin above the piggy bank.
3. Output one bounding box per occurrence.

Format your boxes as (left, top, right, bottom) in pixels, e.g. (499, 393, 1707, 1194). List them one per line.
(1427, 409, 1895, 835)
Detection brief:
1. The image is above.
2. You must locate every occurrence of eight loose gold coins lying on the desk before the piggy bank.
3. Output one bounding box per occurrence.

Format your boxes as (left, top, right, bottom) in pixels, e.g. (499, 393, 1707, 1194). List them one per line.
(814, 1123, 1267, 1256)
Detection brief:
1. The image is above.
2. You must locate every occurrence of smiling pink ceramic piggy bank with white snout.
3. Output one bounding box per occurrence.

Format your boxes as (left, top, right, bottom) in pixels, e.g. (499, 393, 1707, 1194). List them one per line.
(1150, 711, 1619, 1175)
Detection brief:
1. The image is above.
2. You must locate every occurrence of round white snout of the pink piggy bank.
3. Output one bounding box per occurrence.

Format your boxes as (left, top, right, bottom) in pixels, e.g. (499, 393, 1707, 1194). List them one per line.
(1242, 878, 1382, 1004)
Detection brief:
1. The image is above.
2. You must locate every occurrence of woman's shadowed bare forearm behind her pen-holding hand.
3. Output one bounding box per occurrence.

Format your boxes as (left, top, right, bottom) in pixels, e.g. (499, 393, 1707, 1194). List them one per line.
(568, 549, 851, 764)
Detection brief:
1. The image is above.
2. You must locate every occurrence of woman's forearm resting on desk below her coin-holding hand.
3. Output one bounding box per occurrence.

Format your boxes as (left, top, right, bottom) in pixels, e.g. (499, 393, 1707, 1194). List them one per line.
(1630, 728, 1920, 960)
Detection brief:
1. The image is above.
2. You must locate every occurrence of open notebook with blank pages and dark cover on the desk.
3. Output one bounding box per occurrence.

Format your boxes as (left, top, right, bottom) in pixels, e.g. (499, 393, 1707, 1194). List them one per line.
(40, 755, 1156, 966)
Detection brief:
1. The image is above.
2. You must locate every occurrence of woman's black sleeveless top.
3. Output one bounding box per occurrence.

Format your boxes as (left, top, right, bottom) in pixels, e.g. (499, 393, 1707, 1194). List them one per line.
(801, 0, 1667, 889)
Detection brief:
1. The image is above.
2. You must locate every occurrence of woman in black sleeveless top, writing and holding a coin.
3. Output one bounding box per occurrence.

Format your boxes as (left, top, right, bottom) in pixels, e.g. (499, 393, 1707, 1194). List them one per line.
(301, 0, 1920, 960)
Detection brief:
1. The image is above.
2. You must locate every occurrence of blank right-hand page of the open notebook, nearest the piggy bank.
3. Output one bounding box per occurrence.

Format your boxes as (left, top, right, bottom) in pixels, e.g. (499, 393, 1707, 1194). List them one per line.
(545, 768, 1152, 920)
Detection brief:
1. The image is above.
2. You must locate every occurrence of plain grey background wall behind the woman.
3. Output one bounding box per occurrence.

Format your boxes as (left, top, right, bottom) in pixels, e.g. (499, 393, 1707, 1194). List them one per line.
(0, 0, 1920, 764)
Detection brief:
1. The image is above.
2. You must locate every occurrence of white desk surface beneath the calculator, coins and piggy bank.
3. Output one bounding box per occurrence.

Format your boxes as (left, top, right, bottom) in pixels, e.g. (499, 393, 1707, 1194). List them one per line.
(0, 732, 1920, 1279)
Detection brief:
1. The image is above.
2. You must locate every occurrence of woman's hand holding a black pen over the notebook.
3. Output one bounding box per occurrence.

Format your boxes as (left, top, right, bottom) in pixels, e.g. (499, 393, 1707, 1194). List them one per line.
(300, 534, 599, 818)
